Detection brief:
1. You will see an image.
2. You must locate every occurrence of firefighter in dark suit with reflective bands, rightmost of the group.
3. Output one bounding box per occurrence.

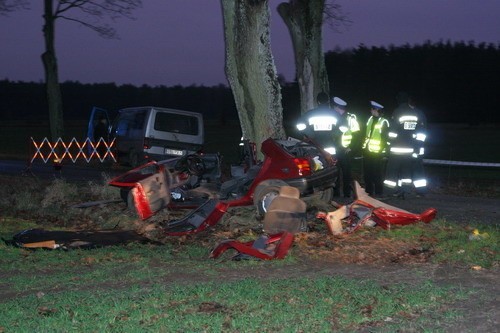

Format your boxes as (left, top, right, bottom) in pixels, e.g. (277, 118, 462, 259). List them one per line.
(384, 93, 427, 196)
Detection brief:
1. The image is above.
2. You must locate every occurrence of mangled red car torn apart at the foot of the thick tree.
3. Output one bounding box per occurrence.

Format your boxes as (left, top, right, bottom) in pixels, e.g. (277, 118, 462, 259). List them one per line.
(109, 138, 338, 235)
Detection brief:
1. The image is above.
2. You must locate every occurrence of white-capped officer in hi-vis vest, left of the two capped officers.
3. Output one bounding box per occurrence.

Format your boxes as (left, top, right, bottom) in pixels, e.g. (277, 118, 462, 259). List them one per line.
(332, 97, 360, 198)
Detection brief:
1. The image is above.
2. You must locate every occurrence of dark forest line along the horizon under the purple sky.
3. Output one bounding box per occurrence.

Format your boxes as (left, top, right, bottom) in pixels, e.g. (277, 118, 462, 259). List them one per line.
(0, 42, 500, 128)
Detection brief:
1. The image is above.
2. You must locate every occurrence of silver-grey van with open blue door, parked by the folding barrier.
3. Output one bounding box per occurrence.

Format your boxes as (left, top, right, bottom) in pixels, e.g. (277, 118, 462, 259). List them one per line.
(88, 106, 204, 167)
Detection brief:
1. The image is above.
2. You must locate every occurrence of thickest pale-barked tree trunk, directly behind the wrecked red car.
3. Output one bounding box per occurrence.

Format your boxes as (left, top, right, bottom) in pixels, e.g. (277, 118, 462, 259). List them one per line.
(221, 0, 285, 157)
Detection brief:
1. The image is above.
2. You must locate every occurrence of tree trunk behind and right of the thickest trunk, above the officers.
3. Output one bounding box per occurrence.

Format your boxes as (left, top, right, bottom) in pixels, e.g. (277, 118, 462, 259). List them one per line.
(278, 0, 329, 113)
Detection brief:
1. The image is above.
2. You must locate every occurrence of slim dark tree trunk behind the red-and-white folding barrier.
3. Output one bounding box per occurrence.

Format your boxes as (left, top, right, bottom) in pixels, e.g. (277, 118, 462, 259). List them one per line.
(42, 0, 64, 141)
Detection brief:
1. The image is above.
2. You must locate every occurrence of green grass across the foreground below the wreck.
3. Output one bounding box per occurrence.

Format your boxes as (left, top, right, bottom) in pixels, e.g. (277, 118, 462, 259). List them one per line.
(0, 239, 468, 332)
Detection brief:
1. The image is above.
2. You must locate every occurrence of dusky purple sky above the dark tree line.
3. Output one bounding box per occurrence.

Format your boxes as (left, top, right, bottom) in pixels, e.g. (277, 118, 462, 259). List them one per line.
(0, 0, 500, 86)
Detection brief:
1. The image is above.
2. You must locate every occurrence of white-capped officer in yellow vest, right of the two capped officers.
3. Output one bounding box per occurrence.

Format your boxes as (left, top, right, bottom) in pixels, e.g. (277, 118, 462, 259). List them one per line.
(363, 101, 389, 198)
